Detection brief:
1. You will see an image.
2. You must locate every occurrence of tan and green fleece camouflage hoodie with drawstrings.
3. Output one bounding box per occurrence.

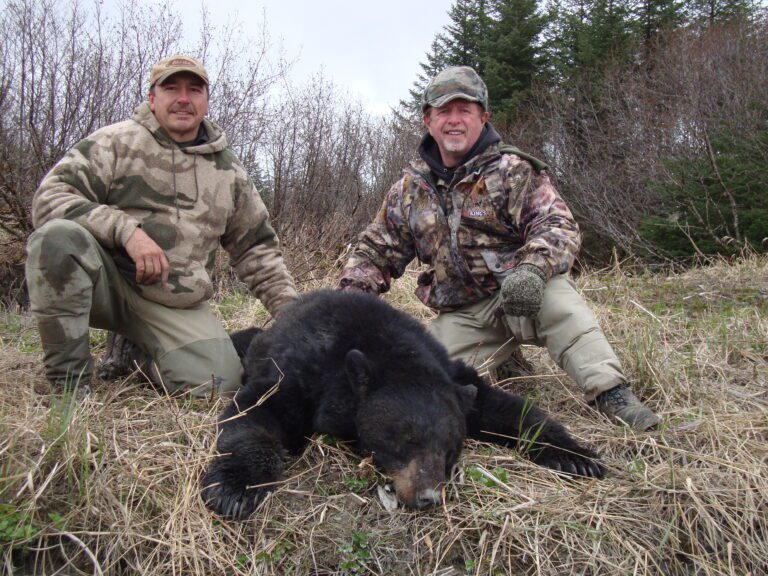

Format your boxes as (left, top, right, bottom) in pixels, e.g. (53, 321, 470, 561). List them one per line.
(32, 102, 297, 315)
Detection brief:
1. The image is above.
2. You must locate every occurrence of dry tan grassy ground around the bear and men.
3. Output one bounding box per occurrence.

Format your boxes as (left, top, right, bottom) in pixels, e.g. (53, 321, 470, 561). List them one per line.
(0, 258, 768, 575)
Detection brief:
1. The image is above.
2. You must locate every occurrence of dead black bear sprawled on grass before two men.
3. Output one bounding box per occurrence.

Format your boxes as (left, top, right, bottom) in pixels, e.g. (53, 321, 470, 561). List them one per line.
(202, 290, 604, 518)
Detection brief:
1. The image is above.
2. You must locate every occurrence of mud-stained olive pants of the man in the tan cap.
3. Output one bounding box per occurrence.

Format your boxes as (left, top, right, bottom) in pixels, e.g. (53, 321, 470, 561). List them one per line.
(26, 220, 242, 396)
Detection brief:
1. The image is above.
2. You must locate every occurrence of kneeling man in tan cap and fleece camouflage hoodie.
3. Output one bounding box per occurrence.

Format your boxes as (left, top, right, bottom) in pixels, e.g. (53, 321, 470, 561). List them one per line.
(26, 55, 297, 396)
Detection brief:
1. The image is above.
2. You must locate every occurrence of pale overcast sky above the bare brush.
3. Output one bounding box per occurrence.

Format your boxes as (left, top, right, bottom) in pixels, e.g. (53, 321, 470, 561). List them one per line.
(180, 0, 452, 113)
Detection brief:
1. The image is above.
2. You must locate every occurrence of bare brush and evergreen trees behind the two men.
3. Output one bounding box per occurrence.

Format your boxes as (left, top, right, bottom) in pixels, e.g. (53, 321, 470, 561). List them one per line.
(0, 0, 768, 288)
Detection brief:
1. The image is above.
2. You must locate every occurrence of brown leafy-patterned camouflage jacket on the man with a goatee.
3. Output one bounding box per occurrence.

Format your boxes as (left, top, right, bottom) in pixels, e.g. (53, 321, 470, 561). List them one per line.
(339, 144, 581, 310)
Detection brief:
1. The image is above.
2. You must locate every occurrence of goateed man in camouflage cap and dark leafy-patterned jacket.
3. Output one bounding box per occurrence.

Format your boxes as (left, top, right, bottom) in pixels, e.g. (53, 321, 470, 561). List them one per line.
(339, 66, 659, 430)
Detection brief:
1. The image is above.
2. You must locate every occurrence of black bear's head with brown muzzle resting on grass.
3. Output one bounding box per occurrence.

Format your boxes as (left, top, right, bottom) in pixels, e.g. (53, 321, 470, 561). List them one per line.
(346, 350, 477, 508)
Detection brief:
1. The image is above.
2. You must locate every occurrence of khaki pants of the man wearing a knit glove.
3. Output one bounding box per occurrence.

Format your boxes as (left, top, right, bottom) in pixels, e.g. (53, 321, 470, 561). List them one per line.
(429, 275, 627, 402)
